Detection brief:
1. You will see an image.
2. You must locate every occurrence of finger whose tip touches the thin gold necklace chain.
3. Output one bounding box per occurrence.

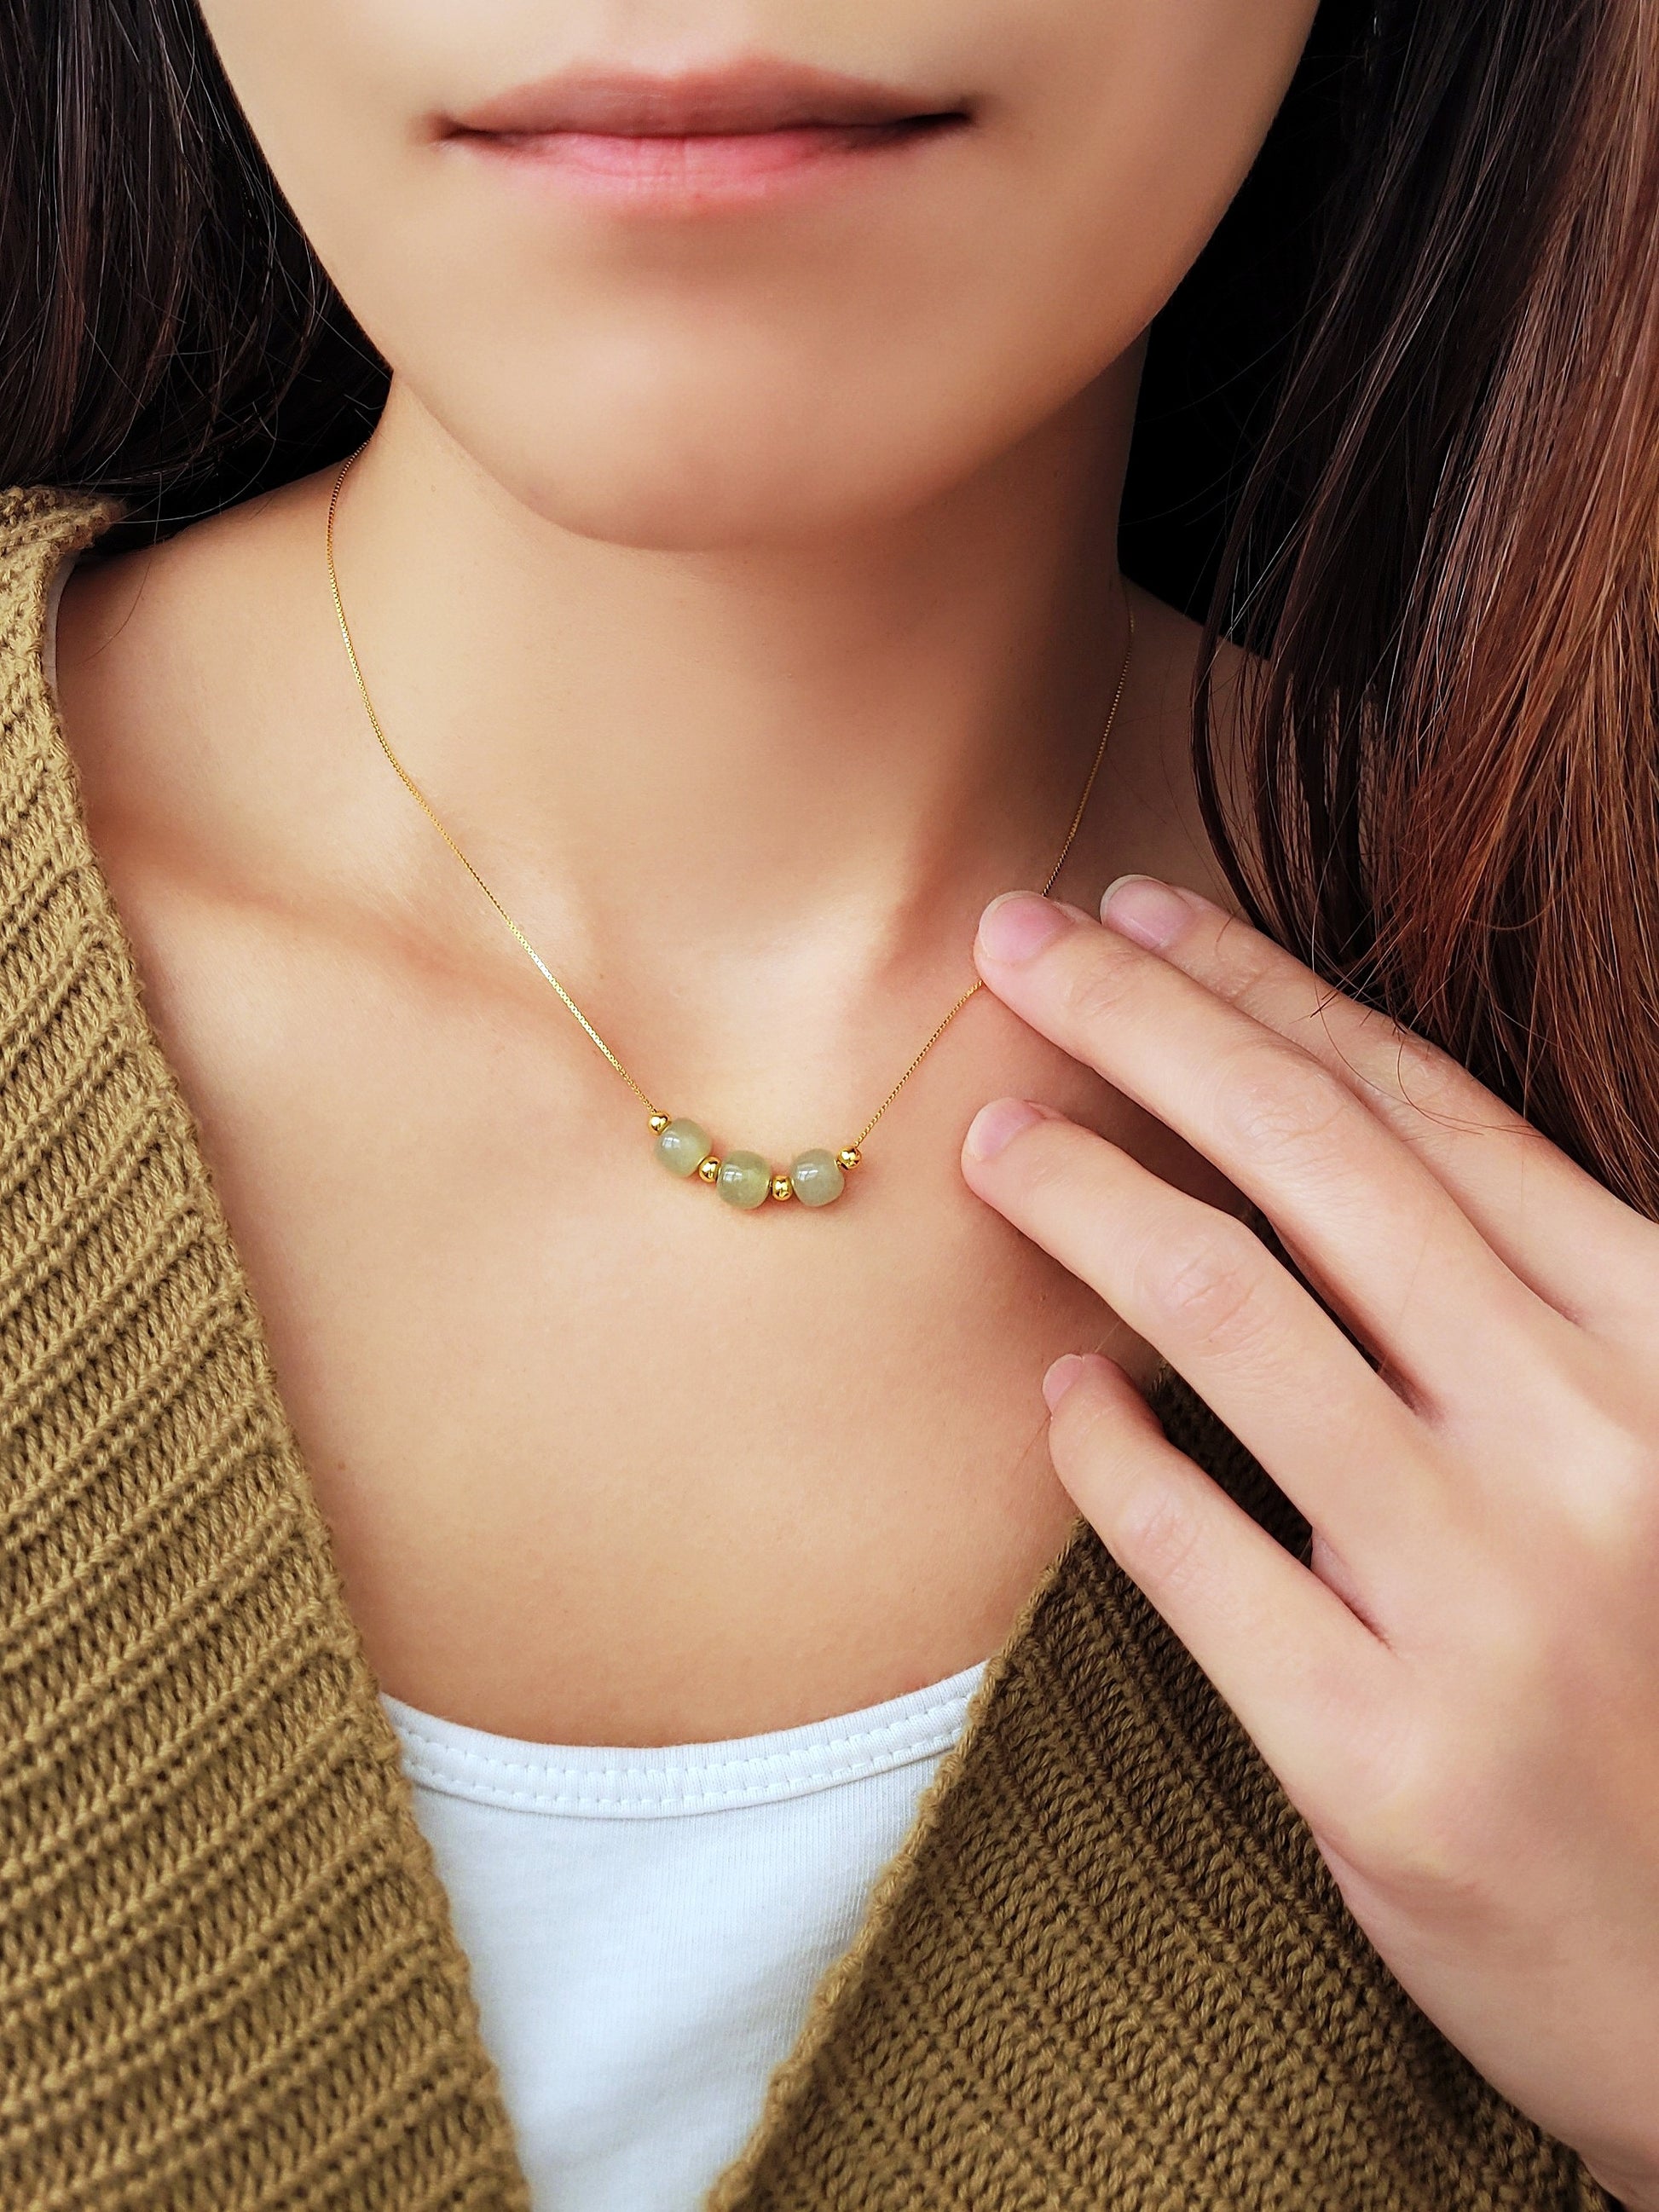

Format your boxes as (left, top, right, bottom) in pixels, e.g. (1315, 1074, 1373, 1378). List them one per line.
(975, 898, 1564, 1405)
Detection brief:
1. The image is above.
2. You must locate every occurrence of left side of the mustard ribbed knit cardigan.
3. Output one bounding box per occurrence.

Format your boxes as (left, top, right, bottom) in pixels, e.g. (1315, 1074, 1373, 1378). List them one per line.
(0, 491, 529, 2212)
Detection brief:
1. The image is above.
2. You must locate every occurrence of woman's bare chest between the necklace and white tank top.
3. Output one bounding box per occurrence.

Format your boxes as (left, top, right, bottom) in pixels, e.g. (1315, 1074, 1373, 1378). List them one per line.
(97, 854, 1229, 1743)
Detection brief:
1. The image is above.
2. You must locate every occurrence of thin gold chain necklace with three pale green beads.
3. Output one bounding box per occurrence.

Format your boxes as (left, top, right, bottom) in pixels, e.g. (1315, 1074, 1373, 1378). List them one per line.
(323, 447, 1135, 1208)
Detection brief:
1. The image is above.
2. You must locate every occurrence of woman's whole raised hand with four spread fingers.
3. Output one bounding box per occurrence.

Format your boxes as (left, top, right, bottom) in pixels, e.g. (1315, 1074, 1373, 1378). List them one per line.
(962, 876, 1659, 2212)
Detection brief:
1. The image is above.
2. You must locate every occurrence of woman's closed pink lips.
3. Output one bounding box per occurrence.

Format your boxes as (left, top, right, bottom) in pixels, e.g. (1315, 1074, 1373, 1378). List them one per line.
(440, 60, 968, 205)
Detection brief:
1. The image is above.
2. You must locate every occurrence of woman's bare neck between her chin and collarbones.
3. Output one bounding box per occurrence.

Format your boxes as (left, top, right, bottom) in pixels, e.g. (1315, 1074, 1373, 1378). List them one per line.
(334, 363, 1135, 962)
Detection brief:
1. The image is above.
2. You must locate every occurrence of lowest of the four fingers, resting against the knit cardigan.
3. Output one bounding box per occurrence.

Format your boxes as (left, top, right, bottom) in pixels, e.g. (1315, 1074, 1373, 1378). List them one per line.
(1049, 1356, 1394, 1829)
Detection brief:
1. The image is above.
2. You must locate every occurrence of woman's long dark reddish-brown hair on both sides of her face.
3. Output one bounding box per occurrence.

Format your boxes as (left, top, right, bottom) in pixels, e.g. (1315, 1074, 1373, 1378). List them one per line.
(0, 0, 1659, 1216)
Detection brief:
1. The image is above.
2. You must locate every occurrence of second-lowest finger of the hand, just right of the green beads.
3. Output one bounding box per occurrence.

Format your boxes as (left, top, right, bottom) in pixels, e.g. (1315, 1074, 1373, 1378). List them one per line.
(962, 1100, 1447, 1566)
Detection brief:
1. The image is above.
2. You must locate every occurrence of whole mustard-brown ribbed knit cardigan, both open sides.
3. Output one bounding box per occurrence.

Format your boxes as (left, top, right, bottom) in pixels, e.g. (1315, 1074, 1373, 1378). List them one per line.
(0, 488, 1610, 2212)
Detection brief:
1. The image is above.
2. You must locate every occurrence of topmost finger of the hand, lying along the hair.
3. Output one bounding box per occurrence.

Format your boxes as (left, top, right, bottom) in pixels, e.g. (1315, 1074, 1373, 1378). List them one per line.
(1101, 876, 1659, 1330)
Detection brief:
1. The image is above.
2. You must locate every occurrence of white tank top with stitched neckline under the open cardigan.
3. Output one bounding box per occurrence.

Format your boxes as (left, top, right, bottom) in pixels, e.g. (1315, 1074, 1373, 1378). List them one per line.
(380, 1663, 985, 2212)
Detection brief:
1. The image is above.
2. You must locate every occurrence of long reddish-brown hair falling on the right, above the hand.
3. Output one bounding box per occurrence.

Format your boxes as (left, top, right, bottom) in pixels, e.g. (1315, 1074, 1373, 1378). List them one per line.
(1197, 0, 1659, 1216)
